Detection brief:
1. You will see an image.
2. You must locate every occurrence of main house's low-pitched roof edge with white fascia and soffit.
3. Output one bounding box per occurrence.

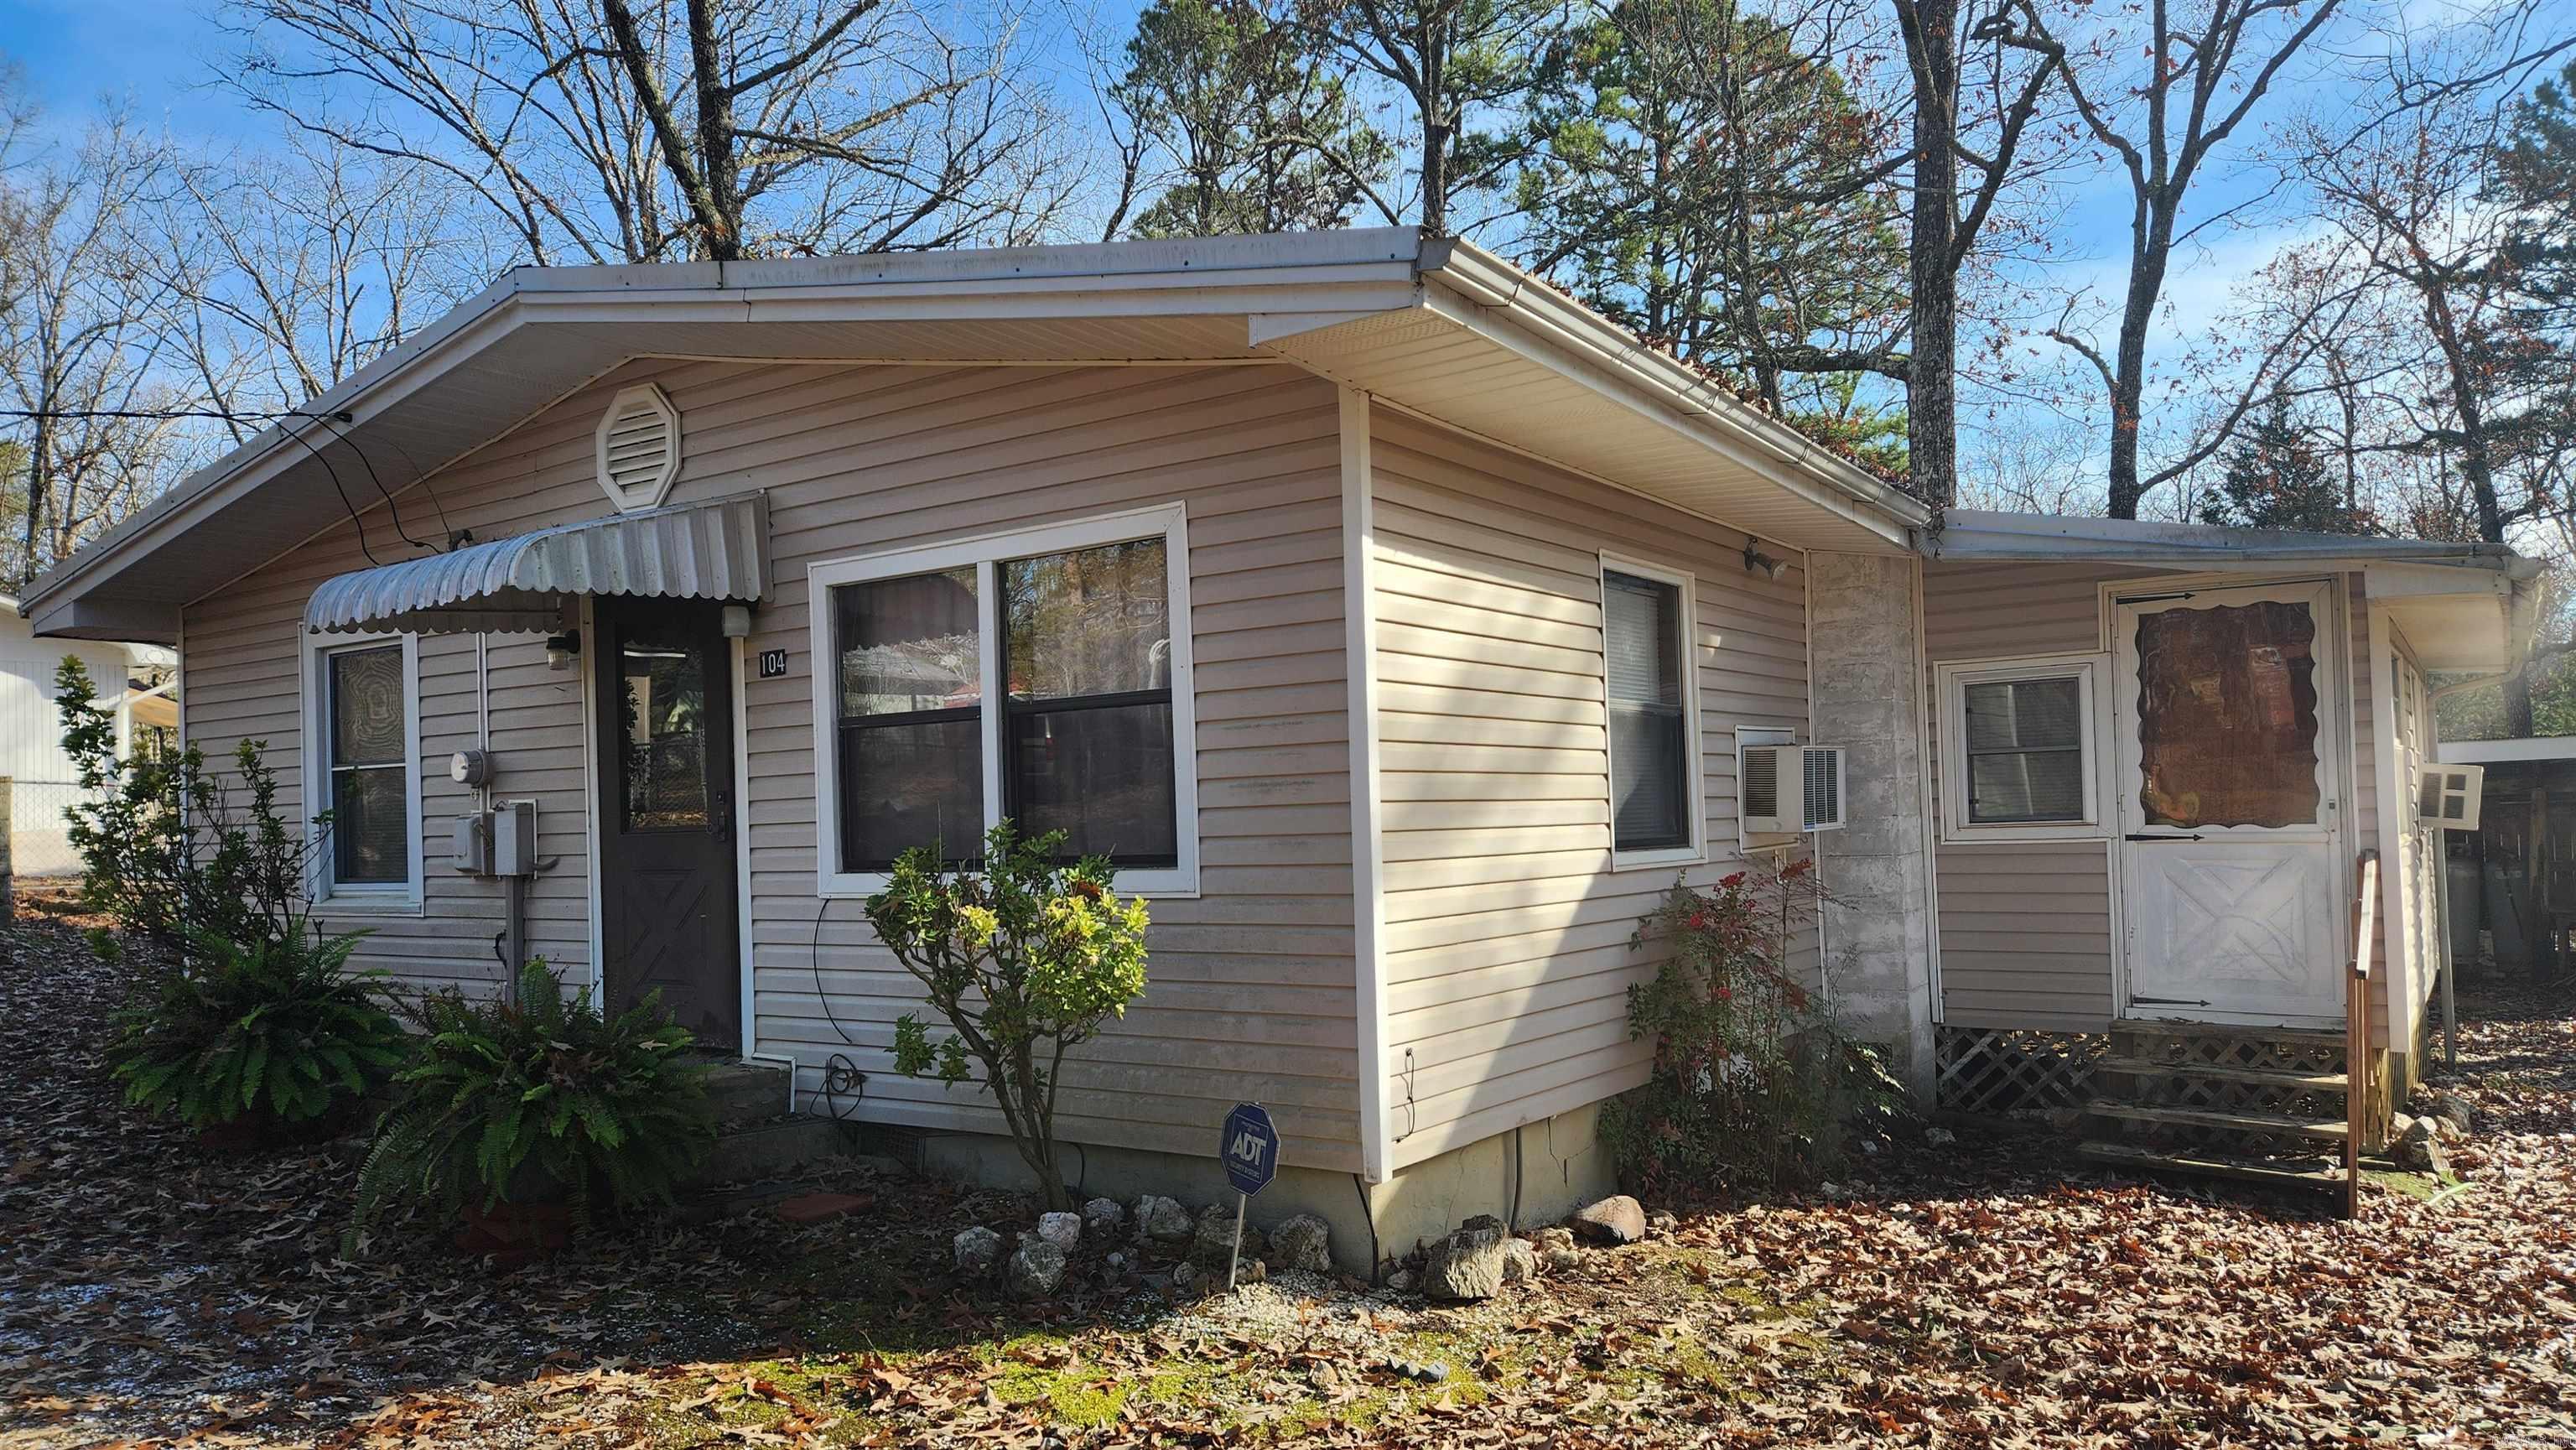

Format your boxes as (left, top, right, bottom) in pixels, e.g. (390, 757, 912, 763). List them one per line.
(23, 226, 1927, 642)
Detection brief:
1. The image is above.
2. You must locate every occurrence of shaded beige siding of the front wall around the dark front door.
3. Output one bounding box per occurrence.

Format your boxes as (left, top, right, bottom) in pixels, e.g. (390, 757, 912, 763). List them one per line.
(185, 361, 1358, 1169)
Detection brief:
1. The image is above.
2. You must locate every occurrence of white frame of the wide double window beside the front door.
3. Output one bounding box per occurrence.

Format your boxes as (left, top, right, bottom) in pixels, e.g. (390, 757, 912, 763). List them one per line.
(807, 505, 1197, 899)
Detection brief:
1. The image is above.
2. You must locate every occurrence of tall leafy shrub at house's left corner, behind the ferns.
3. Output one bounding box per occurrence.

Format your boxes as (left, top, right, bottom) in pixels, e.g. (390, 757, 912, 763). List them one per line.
(55, 654, 330, 955)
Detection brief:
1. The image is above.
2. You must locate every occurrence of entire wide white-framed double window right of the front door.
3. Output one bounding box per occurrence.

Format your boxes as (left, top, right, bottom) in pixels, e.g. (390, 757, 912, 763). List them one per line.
(809, 510, 1197, 894)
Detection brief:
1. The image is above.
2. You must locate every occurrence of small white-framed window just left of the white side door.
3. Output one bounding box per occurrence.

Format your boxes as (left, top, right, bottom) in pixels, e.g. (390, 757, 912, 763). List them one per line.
(1940, 654, 2102, 839)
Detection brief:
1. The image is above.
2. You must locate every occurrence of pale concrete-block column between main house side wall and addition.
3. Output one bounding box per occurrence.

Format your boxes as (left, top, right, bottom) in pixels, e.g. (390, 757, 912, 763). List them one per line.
(1805, 553, 1932, 1102)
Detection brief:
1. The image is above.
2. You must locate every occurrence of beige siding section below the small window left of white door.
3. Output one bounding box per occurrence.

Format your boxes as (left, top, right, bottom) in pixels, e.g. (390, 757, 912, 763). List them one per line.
(1937, 839, 2112, 1032)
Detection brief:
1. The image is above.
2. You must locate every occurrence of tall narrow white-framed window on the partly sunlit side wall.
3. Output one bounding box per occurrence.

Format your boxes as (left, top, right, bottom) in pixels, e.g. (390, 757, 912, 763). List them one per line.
(1602, 569, 1692, 850)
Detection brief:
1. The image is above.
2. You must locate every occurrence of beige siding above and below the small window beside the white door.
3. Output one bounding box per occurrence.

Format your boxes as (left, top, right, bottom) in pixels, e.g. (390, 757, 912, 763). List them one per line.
(1924, 561, 2146, 1032)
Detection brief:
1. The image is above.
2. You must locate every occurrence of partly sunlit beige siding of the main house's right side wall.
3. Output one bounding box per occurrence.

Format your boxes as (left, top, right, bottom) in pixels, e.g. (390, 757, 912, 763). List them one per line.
(1370, 409, 1809, 1167)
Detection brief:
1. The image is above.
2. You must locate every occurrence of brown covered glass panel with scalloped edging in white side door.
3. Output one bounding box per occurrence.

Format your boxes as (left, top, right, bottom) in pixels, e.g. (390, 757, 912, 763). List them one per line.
(2138, 600, 2321, 829)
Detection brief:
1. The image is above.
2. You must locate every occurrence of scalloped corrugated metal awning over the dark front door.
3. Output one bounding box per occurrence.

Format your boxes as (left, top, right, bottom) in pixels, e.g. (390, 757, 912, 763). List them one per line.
(304, 495, 771, 633)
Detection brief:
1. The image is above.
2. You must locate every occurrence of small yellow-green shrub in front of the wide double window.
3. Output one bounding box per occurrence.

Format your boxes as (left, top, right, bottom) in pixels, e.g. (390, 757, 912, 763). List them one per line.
(868, 822, 1146, 1208)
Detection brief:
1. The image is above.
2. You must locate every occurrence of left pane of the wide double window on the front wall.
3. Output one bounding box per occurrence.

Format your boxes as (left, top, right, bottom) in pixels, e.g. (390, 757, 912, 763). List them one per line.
(832, 564, 984, 871)
